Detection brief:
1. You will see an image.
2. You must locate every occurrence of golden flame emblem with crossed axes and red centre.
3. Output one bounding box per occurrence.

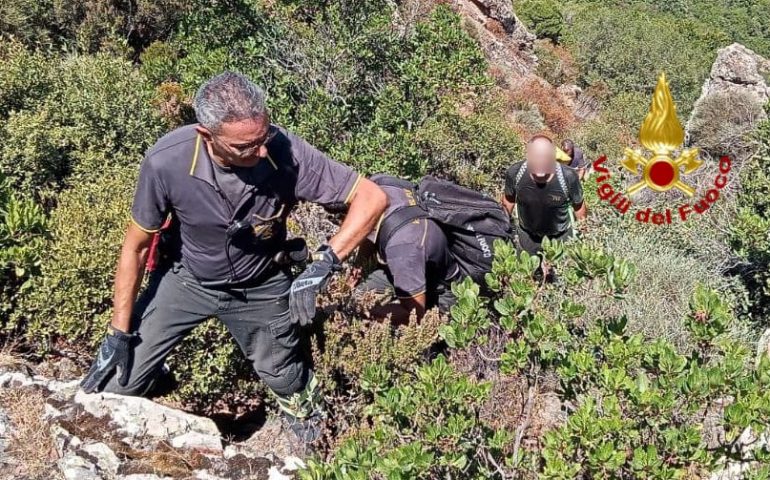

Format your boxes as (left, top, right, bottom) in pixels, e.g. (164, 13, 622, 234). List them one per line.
(621, 73, 703, 197)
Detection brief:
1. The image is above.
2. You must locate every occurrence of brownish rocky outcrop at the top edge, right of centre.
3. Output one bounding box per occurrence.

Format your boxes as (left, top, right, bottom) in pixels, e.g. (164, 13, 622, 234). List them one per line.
(452, 0, 537, 85)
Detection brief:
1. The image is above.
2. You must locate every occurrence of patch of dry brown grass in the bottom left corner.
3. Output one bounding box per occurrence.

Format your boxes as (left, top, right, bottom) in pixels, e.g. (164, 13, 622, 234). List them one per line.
(0, 388, 60, 479)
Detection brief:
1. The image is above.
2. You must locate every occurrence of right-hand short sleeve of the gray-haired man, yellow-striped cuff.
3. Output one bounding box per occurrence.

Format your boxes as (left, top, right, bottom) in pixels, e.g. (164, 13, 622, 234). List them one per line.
(288, 134, 361, 206)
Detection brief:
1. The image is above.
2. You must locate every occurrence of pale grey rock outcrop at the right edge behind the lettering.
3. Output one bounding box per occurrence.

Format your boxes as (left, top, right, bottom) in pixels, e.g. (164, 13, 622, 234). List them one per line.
(686, 43, 770, 158)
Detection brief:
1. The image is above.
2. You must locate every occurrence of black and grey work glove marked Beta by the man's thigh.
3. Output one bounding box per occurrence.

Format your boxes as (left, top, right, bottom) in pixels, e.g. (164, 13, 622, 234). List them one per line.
(289, 245, 342, 326)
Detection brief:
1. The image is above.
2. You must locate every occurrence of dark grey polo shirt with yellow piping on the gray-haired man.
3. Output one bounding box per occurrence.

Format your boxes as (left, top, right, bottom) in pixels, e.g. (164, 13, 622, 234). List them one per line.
(131, 125, 361, 282)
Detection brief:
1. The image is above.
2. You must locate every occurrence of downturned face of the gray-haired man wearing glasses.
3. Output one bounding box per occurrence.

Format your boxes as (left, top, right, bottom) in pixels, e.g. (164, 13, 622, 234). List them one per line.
(198, 115, 275, 167)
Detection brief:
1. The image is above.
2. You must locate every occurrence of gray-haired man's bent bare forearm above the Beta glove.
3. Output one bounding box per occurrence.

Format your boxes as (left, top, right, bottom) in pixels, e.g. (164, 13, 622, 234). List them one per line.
(329, 180, 388, 260)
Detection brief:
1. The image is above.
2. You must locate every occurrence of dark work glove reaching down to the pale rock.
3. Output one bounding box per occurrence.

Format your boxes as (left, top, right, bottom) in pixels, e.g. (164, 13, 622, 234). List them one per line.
(80, 327, 134, 393)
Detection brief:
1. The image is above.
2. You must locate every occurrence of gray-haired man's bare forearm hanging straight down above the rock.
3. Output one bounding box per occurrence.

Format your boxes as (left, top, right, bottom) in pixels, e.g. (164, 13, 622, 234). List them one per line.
(112, 246, 148, 332)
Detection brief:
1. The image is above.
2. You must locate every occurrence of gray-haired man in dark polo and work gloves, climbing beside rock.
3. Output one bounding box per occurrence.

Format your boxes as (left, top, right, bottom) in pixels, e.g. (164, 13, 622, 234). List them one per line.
(82, 72, 387, 441)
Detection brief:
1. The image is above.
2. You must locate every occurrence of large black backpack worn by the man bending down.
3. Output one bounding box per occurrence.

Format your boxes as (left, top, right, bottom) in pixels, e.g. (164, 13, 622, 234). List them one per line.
(372, 175, 513, 285)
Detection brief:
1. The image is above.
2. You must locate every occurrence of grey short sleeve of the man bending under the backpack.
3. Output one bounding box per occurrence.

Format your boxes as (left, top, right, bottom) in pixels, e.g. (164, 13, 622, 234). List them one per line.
(385, 220, 427, 298)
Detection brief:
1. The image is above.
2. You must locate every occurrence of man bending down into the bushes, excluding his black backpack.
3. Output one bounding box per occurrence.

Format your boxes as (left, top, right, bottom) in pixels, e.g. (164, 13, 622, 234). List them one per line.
(356, 176, 461, 325)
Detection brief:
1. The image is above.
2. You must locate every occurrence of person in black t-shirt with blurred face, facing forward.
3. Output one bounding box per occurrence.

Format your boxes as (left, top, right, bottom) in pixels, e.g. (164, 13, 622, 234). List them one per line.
(502, 135, 586, 262)
